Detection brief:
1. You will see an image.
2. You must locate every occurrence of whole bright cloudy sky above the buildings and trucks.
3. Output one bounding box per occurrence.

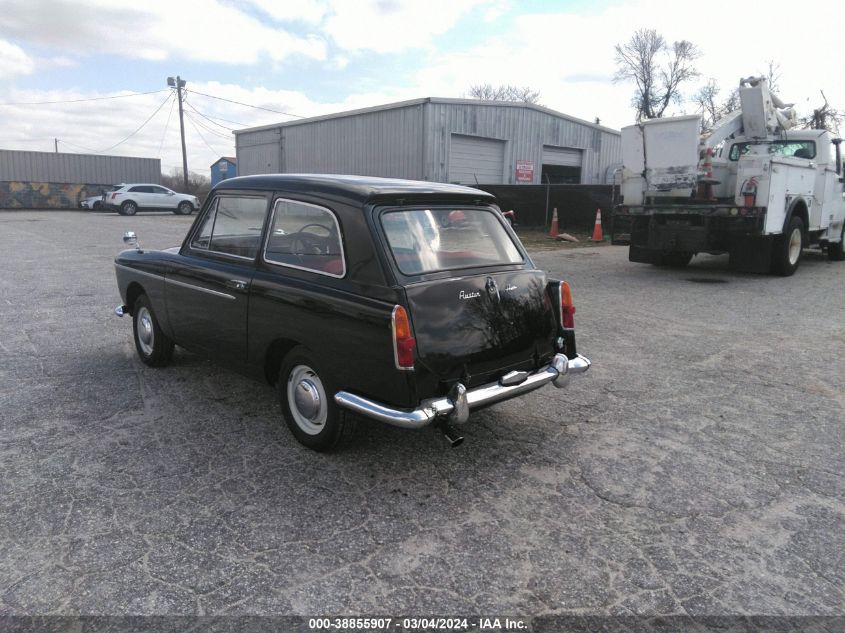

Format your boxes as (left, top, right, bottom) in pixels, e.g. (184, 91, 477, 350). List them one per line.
(0, 0, 845, 174)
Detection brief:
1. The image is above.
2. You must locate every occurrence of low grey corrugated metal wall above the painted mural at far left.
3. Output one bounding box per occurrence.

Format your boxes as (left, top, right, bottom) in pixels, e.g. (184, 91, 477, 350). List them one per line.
(0, 150, 161, 184)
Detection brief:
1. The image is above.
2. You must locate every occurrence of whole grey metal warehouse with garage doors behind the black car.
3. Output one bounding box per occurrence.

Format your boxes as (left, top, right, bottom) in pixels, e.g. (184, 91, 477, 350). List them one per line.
(235, 98, 622, 185)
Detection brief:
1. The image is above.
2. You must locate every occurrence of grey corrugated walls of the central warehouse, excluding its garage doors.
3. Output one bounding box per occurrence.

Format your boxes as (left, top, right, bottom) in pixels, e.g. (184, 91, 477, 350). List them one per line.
(236, 99, 622, 184)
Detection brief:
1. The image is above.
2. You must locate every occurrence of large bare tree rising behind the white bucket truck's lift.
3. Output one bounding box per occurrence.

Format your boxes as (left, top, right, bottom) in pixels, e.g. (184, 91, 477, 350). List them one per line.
(613, 29, 701, 121)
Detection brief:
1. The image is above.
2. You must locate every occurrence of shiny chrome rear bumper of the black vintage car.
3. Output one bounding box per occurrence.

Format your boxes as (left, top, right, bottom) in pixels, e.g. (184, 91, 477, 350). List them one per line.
(334, 354, 591, 429)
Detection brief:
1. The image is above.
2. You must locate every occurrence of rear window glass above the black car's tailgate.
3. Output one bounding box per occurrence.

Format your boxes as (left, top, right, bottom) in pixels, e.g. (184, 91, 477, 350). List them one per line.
(381, 208, 524, 275)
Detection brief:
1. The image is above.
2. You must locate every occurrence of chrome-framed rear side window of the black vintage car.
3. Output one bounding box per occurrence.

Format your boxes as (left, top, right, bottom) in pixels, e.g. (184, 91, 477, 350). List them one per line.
(264, 199, 346, 277)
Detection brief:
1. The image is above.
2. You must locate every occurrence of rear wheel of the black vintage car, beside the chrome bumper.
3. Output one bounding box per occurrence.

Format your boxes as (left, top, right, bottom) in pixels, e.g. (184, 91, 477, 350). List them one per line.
(279, 347, 352, 451)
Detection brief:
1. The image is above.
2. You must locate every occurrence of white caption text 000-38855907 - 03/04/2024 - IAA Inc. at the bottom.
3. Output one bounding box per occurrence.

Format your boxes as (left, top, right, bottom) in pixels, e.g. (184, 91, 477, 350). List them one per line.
(308, 617, 527, 631)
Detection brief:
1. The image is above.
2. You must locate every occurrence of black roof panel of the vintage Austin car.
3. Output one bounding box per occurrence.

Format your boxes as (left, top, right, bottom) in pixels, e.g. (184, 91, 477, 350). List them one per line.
(209, 174, 495, 202)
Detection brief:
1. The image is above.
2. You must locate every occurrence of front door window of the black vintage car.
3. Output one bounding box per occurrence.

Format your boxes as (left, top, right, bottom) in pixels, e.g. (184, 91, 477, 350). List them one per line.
(191, 196, 267, 259)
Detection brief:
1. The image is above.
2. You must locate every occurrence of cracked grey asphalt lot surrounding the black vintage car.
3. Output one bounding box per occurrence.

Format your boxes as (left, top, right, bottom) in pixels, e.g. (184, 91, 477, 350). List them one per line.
(0, 211, 845, 628)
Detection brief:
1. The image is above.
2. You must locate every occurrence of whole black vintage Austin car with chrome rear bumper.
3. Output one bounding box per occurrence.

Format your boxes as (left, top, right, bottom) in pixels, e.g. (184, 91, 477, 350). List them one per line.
(115, 175, 590, 450)
